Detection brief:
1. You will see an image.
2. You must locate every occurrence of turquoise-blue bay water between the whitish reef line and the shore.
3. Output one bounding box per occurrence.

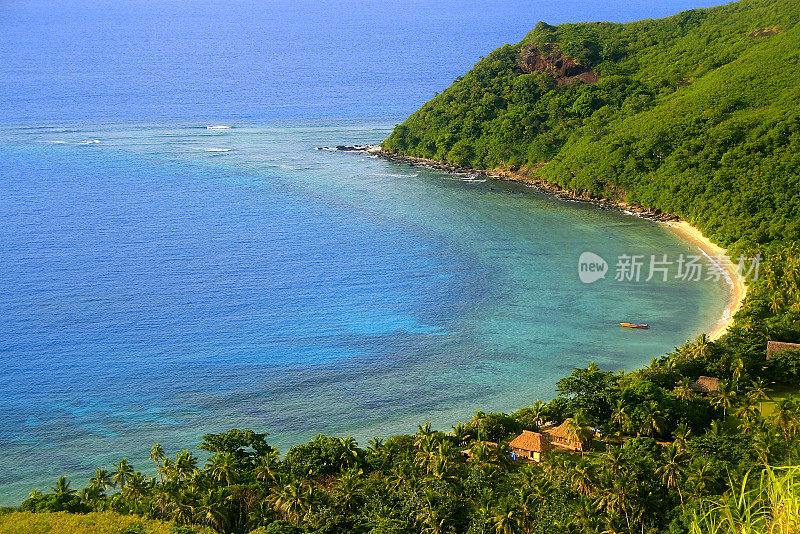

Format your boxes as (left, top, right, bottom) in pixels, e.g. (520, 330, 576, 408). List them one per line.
(0, 122, 727, 502)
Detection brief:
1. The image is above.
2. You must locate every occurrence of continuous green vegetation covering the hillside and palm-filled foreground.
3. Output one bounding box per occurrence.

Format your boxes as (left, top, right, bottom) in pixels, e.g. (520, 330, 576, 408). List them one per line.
(6, 0, 800, 534)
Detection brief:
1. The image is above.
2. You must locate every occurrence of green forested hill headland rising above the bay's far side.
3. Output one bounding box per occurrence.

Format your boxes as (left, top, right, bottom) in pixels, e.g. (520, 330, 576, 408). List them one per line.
(383, 0, 800, 251)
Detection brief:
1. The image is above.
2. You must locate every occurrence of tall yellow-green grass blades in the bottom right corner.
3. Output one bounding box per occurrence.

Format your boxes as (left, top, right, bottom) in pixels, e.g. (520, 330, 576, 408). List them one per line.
(690, 466, 800, 534)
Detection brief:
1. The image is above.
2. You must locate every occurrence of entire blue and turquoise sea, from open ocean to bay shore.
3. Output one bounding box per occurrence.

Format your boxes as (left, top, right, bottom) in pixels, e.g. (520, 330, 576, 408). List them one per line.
(0, 0, 728, 504)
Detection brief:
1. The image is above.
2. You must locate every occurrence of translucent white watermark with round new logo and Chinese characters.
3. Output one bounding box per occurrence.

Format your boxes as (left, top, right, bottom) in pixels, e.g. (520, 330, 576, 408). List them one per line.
(578, 252, 761, 284)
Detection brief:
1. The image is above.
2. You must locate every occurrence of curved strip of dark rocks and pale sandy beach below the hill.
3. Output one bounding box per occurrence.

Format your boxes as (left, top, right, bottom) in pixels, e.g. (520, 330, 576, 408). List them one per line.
(366, 145, 747, 341)
